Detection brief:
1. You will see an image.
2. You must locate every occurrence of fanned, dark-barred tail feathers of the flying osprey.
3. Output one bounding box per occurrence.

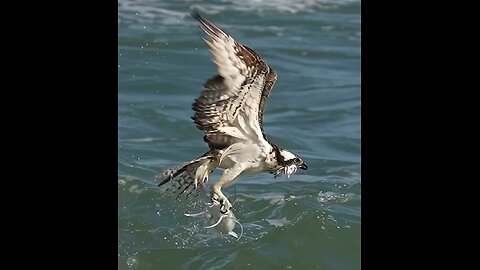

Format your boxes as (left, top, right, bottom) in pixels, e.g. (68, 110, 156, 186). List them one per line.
(156, 151, 219, 197)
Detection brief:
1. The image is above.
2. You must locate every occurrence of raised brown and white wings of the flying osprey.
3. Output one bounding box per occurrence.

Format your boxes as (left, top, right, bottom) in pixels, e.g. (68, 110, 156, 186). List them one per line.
(192, 13, 277, 149)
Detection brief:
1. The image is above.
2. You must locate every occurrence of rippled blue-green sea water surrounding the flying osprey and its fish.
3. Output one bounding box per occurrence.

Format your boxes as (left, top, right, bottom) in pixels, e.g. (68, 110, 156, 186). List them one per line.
(118, 0, 361, 270)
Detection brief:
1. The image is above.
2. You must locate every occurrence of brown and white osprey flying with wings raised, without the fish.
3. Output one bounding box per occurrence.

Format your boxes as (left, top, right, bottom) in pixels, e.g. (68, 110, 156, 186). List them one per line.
(157, 12, 307, 213)
